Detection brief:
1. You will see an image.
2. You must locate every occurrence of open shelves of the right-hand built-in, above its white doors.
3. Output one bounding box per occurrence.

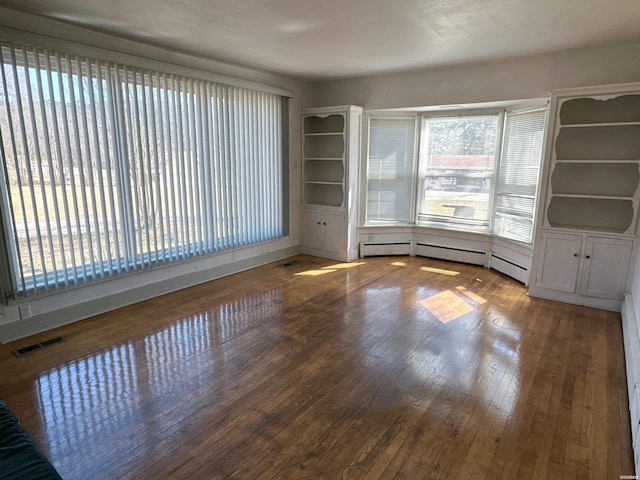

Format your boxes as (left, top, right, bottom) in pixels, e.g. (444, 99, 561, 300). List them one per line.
(546, 94, 640, 234)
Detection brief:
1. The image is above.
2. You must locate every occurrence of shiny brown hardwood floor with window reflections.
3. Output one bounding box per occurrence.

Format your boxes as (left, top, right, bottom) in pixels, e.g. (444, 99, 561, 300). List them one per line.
(0, 255, 634, 480)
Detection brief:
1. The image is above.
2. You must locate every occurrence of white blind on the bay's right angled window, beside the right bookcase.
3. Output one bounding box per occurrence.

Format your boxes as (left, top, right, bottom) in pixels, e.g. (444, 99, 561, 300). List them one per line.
(493, 108, 546, 243)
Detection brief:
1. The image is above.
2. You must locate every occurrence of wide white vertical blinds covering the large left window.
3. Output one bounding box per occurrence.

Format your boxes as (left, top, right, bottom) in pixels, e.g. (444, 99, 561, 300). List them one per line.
(0, 42, 284, 294)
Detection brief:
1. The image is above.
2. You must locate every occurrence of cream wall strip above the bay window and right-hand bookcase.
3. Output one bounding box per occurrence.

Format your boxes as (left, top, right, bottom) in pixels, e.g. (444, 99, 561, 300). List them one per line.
(313, 44, 640, 109)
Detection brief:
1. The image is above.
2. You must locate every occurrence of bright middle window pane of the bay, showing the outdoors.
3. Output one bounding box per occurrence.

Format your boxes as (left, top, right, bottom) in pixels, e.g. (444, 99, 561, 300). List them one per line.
(418, 115, 499, 231)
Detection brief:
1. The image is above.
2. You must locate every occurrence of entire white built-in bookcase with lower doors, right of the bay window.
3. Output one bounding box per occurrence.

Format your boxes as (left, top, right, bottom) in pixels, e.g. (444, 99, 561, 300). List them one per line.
(529, 83, 640, 311)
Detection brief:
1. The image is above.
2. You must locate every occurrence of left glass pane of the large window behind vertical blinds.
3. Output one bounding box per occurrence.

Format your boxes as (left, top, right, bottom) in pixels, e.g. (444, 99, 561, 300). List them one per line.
(0, 45, 122, 291)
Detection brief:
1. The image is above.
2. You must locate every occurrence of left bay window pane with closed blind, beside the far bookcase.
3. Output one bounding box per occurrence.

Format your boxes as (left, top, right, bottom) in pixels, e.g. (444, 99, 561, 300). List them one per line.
(366, 117, 416, 223)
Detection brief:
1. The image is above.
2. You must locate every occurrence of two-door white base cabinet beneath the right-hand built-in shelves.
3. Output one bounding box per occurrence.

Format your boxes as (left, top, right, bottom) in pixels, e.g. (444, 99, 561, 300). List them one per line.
(534, 231, 633, 309)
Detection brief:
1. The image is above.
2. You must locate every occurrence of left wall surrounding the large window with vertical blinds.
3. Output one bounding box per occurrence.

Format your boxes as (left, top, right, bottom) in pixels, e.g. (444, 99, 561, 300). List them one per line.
(0, 7, 311, 344)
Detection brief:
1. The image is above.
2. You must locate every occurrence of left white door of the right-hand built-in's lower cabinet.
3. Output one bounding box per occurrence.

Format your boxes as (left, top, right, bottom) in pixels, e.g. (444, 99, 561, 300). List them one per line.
(537, 233, 582, 293)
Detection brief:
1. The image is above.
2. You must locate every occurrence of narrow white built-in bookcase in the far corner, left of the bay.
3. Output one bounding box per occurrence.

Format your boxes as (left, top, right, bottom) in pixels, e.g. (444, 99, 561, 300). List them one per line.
(301, 105, 362, 261)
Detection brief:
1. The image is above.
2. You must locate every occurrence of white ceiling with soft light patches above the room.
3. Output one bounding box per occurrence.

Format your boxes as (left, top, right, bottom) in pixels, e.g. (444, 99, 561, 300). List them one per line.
(0, 0, 640, 80)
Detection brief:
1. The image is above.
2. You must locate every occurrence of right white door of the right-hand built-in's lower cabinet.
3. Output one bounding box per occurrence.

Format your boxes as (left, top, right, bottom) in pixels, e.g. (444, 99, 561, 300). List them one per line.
(580, 237, 632, 300)
